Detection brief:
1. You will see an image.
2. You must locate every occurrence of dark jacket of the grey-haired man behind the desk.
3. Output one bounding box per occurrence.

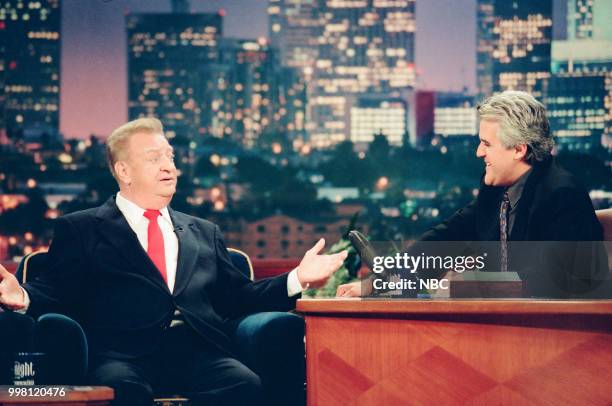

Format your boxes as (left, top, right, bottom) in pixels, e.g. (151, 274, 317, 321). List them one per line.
(411, 159, 608, 297)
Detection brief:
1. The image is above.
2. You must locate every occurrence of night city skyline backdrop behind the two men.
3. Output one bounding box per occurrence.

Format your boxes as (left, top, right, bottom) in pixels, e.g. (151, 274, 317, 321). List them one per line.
(0, 0, 612, 259)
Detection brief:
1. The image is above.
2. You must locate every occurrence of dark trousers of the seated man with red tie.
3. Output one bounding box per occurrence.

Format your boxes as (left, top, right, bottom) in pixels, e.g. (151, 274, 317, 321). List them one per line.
(88, 325, 262, 406)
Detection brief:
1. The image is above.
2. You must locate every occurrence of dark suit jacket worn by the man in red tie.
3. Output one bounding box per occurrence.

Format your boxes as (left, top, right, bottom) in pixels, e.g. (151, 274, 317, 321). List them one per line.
(24, 198, 296, 358)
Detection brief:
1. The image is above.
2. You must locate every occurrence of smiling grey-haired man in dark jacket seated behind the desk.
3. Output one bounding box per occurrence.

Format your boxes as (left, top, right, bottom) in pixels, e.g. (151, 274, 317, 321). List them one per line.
(337, 91, 608, 297)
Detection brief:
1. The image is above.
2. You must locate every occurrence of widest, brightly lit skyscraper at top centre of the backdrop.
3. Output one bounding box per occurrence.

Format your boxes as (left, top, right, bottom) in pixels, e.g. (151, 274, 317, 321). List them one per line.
(268, 0, 416, 148)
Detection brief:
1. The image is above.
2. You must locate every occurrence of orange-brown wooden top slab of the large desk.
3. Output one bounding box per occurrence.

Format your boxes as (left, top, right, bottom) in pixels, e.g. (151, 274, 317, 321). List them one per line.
(296, 298, 612, 316)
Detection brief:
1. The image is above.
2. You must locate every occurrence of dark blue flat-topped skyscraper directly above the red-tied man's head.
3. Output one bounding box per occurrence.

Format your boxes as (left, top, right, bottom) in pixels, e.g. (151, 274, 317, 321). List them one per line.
(126, 13, 225, 140)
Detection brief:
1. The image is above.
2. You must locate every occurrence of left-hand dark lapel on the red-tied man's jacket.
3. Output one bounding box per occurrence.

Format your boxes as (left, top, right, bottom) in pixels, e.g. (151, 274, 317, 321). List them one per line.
(96, 196, 170, 293)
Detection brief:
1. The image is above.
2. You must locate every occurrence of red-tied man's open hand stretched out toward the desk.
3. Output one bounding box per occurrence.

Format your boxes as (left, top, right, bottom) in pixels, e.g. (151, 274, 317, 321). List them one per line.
(297, 238, 348, 288)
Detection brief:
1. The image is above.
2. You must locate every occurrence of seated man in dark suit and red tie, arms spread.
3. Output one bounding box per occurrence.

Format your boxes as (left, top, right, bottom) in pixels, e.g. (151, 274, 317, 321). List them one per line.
(0, 118, 346, 405)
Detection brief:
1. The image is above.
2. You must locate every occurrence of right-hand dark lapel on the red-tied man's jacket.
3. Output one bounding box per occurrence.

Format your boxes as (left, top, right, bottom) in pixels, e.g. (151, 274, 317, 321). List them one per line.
(168, 208, 199, 296)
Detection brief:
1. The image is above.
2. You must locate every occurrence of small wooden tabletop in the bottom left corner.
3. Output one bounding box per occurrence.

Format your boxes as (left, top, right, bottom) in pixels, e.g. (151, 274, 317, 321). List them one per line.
(0, 385, 115, 406)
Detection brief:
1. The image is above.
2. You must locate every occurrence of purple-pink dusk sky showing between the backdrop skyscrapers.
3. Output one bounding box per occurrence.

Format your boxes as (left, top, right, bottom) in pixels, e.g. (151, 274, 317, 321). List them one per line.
(60, 0, 563, 138)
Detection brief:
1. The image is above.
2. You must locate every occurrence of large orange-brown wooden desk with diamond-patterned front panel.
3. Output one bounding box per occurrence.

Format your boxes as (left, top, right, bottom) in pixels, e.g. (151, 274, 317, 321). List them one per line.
(297, 299, 612, 406)
